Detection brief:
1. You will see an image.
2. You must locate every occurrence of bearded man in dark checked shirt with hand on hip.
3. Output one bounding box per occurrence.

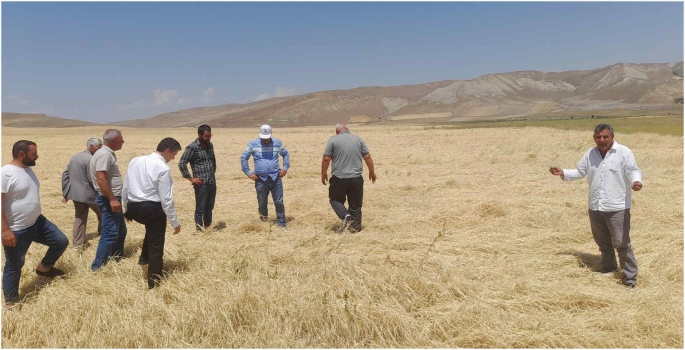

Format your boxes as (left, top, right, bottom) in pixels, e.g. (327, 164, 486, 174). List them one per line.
(178, 124, 216, 231)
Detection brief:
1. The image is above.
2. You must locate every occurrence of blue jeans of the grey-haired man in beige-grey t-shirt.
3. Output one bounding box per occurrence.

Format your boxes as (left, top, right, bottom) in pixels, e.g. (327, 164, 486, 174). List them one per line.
(90, 194, 127, 271)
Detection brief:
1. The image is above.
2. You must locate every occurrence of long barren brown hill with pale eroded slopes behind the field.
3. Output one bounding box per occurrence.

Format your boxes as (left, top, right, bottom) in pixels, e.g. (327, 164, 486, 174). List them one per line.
(119, 61, 683, 127)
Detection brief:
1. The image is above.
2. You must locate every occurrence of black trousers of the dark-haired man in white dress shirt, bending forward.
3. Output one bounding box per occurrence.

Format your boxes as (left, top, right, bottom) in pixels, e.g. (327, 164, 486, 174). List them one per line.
(126, 202, 166, 289)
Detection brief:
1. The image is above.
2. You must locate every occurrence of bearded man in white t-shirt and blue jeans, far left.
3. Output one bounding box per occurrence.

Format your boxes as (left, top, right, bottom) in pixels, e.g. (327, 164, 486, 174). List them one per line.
(2, 140, 69, 308)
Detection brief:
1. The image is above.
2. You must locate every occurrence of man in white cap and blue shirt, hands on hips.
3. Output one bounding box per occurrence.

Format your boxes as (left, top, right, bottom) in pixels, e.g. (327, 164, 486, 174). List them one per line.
(240, 125, 290, 227)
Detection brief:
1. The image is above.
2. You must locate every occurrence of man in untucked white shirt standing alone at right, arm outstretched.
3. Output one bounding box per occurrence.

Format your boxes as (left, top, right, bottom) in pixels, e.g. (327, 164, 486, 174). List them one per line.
(549, 124, 642, 288)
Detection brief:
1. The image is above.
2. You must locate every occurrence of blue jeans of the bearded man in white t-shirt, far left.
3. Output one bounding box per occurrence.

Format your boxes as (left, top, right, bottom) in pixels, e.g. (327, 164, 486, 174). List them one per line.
(2, 215, 69, 303)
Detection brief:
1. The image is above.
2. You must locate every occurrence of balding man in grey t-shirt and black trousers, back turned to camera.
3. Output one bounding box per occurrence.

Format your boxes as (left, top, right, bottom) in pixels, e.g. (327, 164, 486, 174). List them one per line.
(321, 123, 376, 232)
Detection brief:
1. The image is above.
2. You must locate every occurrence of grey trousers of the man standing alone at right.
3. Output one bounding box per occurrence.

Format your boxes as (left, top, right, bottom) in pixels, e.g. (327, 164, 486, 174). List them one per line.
(588, 209, 637, 284)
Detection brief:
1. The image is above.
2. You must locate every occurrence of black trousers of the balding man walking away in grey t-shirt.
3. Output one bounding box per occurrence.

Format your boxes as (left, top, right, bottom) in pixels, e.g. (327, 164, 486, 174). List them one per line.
(328, 176, 364, 231)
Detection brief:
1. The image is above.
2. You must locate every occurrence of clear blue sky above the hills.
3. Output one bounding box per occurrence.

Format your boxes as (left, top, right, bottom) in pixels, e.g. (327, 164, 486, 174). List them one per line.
(2, 2, 683, 122)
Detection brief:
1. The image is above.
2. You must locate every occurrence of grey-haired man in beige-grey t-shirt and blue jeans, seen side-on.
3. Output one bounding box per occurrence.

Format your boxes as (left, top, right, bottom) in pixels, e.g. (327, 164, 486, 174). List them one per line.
(89, 129, 126, 271)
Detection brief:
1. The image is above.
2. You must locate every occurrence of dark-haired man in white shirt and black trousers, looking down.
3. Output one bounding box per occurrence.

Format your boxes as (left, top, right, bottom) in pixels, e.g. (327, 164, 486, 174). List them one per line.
(122, 137, 181, 289)
